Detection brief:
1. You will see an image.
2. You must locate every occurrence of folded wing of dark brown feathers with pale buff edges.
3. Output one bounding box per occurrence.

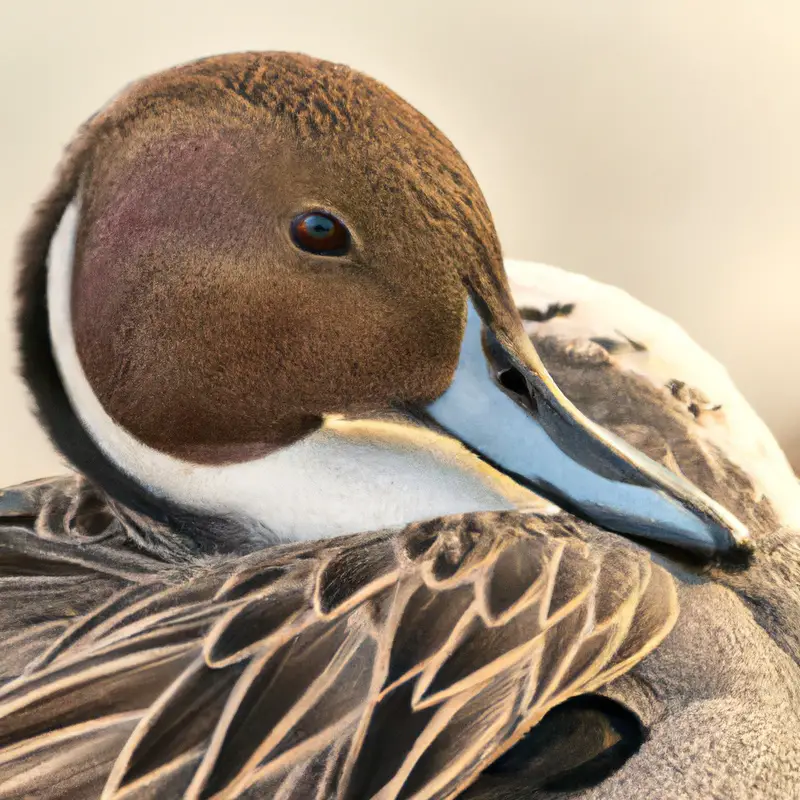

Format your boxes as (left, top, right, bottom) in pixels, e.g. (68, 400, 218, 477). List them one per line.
(0, 496, 677, 800)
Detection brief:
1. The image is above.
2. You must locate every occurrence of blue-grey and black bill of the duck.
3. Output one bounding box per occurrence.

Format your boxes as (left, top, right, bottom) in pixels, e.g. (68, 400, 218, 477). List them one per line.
(426, 302, 748, 553)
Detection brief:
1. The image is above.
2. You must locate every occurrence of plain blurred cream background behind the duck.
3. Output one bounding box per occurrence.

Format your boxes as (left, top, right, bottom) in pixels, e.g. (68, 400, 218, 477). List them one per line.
(0, 0, 800, 485)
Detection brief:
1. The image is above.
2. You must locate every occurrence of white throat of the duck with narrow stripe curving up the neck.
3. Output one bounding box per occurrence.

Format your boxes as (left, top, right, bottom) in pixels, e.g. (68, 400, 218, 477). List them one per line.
(47, 202, 544, 540)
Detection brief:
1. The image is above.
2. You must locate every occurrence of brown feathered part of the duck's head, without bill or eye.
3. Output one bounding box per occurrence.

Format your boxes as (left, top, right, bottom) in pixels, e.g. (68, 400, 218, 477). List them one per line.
(59, 54, 516, 461)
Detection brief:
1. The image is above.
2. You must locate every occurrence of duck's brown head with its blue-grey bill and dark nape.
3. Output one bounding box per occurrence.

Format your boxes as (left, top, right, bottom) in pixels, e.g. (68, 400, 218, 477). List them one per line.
(20, 53, 746, 550)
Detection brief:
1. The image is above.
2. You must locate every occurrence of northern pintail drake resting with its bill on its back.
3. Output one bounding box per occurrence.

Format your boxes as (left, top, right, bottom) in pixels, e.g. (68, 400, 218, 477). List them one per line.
(0, 53, 800, 800)
